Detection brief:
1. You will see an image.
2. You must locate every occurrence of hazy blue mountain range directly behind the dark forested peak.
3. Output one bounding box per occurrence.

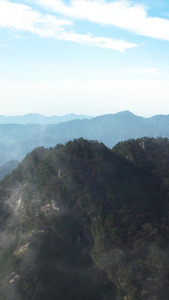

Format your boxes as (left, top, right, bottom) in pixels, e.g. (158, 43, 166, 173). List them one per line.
(0, 111, 169, 169)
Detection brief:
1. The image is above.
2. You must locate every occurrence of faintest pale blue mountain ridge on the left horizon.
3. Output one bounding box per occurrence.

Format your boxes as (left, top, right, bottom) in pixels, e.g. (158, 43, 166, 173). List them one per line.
(0, 114, 92, 125)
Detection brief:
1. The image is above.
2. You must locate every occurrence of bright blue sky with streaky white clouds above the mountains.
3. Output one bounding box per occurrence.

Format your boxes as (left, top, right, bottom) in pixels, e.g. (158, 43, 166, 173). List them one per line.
(0, 0, 169, 117)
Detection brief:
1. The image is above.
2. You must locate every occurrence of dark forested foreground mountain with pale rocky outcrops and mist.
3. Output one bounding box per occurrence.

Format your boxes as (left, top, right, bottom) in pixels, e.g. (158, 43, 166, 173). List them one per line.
(0, 137, 169, 300)
